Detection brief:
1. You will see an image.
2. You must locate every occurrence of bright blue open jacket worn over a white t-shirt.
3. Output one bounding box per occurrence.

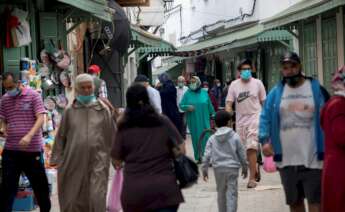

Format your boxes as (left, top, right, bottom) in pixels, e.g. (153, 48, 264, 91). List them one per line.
(259, 78, 328, 161)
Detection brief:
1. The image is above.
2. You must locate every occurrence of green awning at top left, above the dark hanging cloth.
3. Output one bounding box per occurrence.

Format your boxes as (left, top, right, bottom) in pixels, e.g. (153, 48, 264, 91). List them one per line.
(57, 0, 111, 22)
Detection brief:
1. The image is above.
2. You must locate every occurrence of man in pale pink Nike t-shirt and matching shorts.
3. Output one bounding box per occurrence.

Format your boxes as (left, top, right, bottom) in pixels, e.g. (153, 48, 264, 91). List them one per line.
(226, 59, 266, 188)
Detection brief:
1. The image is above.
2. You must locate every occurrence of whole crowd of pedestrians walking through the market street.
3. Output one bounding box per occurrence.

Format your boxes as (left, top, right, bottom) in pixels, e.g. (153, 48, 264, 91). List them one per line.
(0, 52, 345, 212)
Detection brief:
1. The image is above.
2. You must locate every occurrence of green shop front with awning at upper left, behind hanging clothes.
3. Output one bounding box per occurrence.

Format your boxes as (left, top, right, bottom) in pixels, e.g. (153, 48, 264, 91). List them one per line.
(0, 0, 111, 93)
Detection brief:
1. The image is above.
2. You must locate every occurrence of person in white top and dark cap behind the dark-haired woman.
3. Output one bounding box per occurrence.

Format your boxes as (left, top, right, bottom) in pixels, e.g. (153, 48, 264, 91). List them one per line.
(134, 74, 162, 114)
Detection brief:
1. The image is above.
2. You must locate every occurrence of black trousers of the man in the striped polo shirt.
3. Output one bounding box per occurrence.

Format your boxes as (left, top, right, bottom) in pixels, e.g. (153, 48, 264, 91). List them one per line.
(0, 150, 51, 212)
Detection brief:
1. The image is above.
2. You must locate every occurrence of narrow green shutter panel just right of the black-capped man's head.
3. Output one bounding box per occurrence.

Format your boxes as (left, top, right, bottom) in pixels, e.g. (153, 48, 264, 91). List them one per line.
(302, 22, 318, 78)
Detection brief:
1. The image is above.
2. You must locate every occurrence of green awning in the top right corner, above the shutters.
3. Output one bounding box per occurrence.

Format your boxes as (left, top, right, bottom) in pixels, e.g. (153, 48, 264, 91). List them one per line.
(262, 0, 345, 29)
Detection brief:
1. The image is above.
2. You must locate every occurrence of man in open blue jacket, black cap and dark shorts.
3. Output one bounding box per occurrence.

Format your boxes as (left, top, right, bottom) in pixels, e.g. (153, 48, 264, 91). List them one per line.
(259, 52, 329, 212)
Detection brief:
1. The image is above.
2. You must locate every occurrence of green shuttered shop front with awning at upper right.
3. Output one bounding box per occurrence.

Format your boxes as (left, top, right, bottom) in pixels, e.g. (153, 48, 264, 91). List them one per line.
(263, 0, 345, 91)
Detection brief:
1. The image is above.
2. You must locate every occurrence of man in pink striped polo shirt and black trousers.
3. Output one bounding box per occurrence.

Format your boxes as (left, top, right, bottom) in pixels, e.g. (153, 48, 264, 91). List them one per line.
(0, 73, 51, 212)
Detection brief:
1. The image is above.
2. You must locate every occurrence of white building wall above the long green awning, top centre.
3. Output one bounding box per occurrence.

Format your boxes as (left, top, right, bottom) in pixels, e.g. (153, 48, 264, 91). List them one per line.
(162, 0, 300, 46)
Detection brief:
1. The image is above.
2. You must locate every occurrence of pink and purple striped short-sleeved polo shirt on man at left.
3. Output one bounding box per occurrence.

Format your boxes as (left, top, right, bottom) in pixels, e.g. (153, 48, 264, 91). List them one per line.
(0, 88, 46, 152)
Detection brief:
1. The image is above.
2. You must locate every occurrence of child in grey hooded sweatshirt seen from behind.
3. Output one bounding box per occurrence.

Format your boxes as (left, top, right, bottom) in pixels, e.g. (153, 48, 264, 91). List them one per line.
(202, 111, 248, 212)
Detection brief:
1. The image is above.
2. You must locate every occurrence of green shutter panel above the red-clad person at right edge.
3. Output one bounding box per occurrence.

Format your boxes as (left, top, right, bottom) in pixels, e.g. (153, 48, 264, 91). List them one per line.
(322, 18, 338, 91)
